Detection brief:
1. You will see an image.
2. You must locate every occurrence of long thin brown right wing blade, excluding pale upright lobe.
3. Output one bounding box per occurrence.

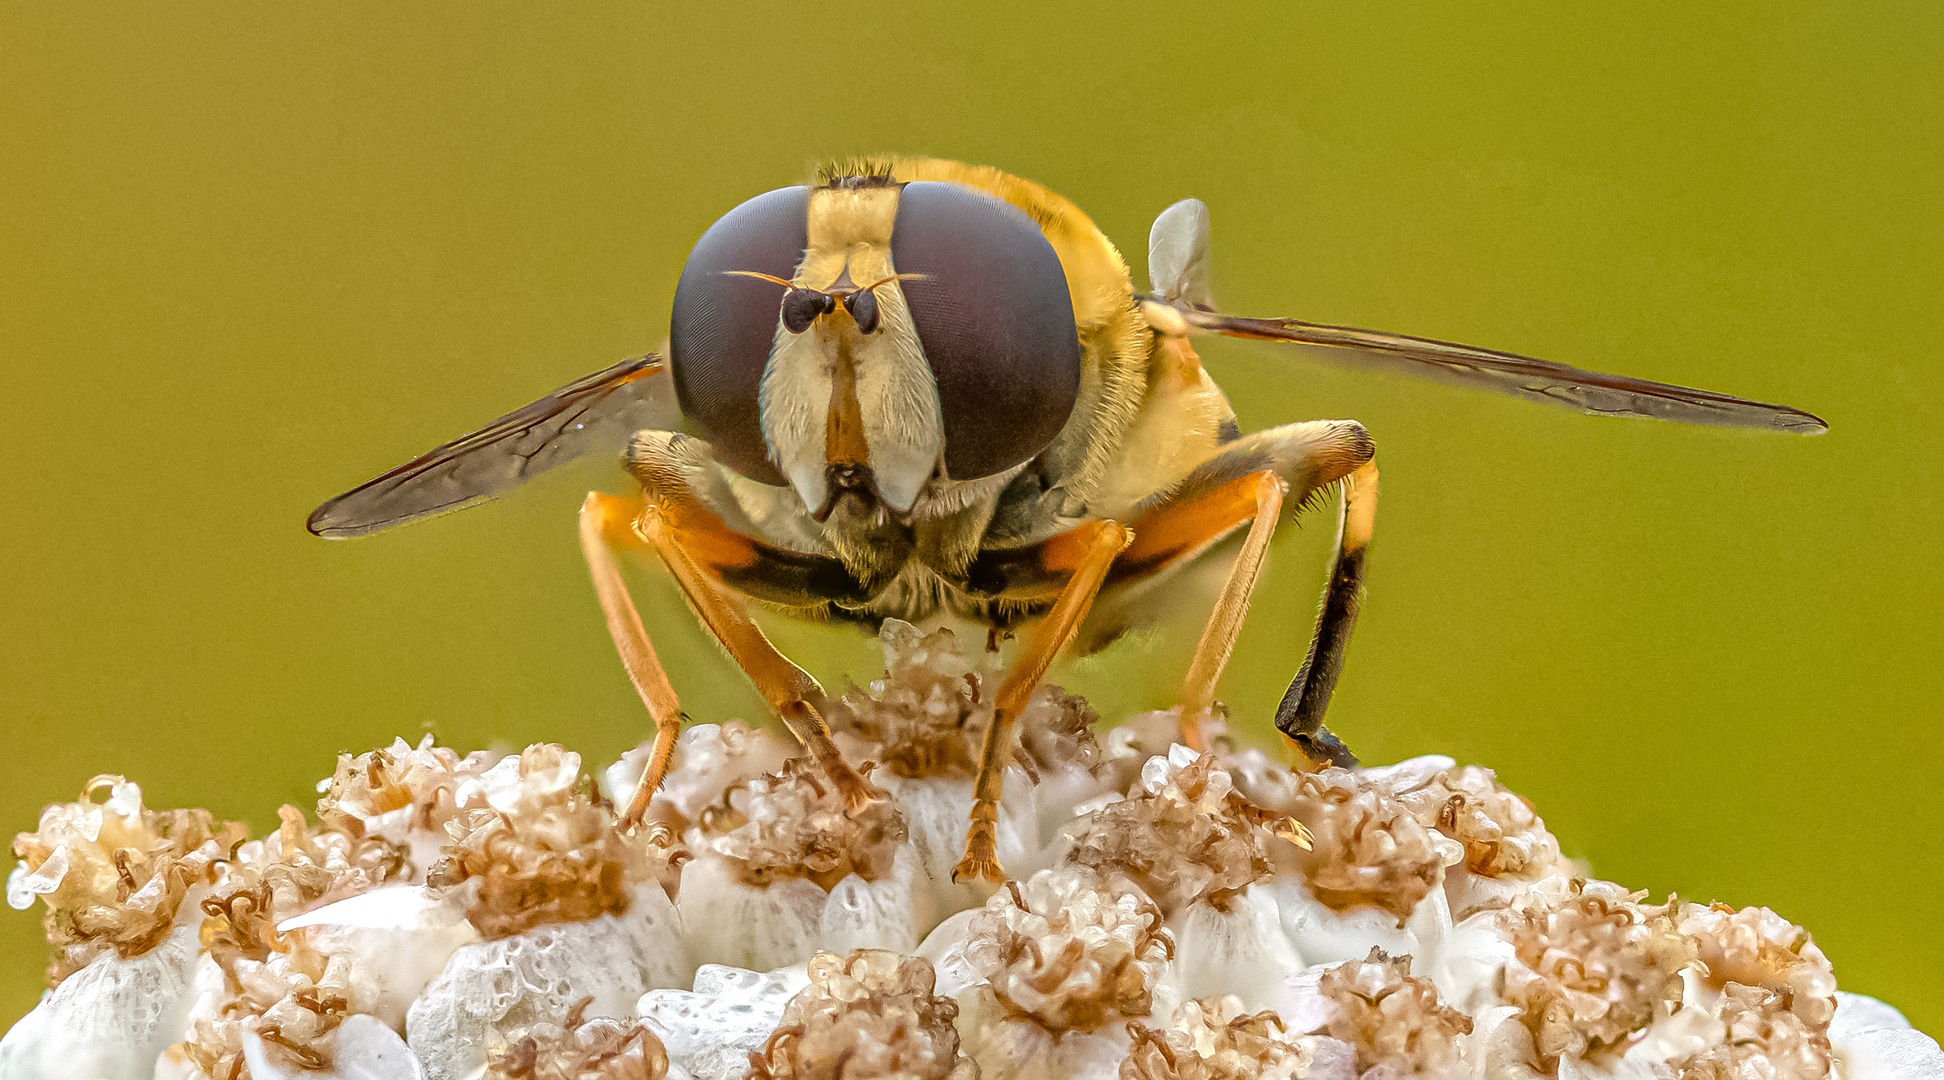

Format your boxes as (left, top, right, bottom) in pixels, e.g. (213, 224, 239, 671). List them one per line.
(1149, 297, 1829, 435)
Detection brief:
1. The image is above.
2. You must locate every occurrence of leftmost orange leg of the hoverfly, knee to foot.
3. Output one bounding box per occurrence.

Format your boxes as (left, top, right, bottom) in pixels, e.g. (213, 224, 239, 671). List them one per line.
(581, 491, 682, 826)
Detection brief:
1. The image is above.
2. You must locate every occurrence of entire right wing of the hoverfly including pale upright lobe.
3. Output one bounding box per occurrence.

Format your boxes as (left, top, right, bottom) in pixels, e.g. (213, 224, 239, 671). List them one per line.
(1139, 198, 1829, 435)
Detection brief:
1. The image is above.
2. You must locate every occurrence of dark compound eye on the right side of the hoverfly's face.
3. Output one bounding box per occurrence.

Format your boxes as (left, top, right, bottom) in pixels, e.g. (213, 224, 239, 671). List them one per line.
(890, 181, 1081, 480)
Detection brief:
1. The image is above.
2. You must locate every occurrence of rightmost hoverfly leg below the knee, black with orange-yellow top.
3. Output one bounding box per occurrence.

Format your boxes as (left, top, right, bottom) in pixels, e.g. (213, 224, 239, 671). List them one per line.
(1275, 460, 1376, 769)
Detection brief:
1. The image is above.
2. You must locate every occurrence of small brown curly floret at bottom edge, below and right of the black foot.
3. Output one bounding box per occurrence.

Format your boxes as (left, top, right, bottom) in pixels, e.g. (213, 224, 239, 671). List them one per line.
(1316, 948, 1472, 1076)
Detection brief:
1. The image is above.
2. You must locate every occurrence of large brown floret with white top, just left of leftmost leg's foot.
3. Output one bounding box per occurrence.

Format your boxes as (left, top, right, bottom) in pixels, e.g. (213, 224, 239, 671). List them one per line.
(428, 742, 680, 940)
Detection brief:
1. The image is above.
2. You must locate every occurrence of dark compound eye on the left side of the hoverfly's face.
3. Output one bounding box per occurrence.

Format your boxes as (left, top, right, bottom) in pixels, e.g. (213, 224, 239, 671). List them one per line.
(669, 186, 811, 486)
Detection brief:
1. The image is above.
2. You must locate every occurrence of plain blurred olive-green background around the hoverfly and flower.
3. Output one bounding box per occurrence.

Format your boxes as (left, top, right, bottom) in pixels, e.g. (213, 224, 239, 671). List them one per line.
(0, 2, 1944, 1031)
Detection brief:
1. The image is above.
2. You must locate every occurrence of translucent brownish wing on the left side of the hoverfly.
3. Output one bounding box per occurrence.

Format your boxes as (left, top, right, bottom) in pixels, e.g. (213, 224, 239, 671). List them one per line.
(309, 355, 680, 540)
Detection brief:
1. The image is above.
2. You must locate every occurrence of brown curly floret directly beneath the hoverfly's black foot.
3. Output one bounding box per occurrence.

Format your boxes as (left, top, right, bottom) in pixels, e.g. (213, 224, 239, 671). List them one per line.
(1295, 769, 1450, 923)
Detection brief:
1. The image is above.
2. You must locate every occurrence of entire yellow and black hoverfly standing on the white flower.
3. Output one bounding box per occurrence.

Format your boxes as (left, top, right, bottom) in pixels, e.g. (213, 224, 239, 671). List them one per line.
(309, 157, 1825, 880)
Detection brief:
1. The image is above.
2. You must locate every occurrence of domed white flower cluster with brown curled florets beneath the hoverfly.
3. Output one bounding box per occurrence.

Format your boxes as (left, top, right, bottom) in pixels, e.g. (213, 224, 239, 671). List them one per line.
(0, 622, 1944, 1080)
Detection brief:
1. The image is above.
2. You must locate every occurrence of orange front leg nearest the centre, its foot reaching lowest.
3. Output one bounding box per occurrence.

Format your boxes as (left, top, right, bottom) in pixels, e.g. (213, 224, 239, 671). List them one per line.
(953, 521, 1133, 882)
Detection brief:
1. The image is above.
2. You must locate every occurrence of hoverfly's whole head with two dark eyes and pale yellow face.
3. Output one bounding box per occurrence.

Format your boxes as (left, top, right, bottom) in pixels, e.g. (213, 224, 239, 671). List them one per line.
(669, 177, 1081, 521)
